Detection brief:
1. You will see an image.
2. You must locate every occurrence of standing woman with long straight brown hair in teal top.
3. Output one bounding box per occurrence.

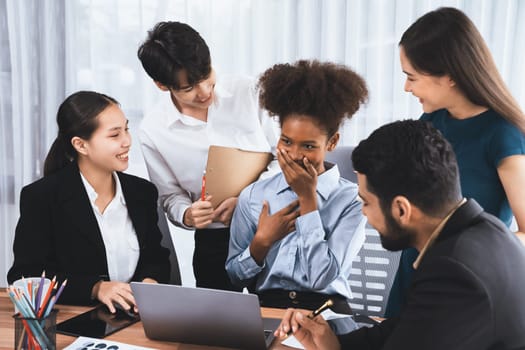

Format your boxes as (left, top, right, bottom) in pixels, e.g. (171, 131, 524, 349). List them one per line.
(385, 8, 525, 317)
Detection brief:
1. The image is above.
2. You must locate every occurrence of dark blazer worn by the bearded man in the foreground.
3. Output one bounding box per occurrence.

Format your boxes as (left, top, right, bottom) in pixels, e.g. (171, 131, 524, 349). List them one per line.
(339, 200, 525, 350)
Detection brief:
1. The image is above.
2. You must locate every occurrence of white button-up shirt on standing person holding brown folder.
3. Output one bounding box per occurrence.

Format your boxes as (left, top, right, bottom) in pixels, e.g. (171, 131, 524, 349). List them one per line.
(140, 78, 279, 228)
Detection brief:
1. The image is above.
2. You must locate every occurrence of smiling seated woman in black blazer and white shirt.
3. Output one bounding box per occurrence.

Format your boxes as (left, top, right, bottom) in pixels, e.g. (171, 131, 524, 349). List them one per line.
(7, 91, 170, 312)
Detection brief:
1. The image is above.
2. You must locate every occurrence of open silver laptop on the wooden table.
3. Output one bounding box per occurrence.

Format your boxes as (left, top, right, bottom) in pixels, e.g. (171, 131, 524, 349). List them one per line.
(131, 282, 280, 350)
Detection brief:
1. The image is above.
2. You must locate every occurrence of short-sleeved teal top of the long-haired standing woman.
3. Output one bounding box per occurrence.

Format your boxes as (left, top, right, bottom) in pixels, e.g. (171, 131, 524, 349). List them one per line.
(421, 109, 525, 226)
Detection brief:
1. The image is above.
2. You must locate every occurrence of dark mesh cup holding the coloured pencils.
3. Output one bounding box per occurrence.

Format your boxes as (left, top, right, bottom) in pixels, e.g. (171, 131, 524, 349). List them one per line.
(13, 310, 58, 350)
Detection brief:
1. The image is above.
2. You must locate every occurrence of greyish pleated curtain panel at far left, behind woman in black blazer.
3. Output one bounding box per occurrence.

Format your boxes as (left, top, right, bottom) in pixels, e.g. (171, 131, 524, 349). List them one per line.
(0, 0, 65, 286)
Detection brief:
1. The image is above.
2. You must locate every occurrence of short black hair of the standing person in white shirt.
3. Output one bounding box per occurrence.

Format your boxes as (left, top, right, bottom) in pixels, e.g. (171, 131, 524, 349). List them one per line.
(137, 22, 211, 90)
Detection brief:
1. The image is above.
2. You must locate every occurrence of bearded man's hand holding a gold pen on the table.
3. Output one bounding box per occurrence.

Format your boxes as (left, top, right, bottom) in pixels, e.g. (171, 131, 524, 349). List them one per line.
(274, 309, 341, 350)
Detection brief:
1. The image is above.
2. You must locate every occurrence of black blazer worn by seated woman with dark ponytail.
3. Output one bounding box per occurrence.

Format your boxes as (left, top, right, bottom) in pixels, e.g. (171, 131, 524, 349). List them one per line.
(7, 163, 170, 305)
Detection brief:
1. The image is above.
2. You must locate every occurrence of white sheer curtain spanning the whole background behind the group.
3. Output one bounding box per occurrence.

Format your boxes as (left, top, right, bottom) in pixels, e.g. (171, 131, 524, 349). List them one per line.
(0, 0, 525, 285)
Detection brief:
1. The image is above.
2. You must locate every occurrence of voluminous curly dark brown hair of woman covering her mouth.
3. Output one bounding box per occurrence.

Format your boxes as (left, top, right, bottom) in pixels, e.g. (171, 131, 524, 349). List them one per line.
(258, 60, 368, 137)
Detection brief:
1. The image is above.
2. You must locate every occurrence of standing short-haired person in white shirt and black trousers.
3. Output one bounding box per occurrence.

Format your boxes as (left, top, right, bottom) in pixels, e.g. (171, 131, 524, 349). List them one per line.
(138, 22, 277, 290)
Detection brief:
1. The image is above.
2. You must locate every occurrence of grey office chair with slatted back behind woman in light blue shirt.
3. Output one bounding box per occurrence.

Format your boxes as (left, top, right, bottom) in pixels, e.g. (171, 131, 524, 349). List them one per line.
(326, 146, 400, 317)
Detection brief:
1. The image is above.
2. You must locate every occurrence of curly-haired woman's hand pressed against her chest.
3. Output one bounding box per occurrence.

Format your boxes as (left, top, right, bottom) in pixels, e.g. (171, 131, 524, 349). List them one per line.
(250, 200, 299, 265)
